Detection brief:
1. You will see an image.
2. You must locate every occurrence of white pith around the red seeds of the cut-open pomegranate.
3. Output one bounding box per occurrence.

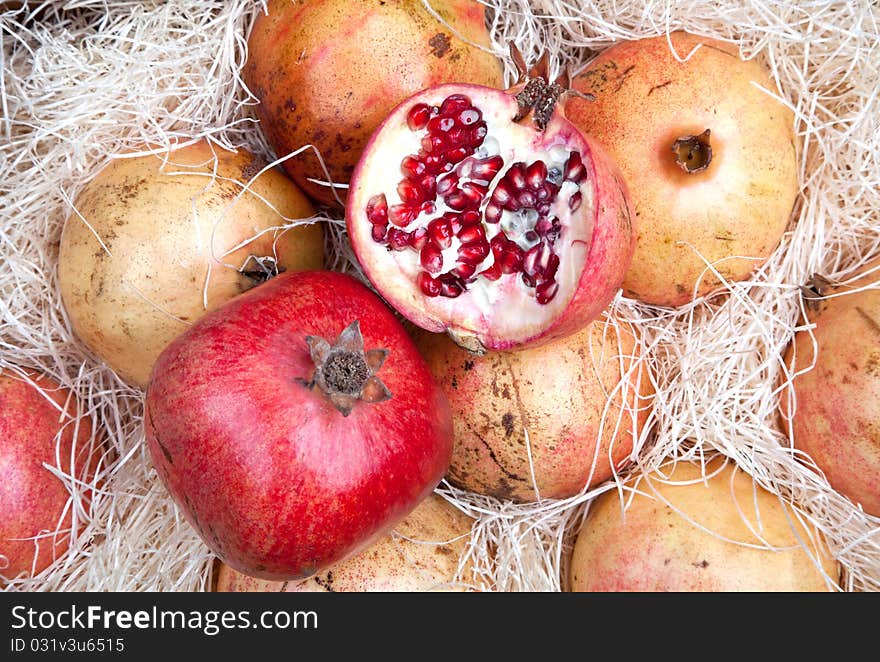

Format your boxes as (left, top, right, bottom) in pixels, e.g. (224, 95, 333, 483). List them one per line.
(354, 86, 594, 343)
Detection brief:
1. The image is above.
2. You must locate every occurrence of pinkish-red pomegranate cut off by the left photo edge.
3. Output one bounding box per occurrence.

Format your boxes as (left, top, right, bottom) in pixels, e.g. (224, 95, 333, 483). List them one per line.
(0, 371, 97, 579)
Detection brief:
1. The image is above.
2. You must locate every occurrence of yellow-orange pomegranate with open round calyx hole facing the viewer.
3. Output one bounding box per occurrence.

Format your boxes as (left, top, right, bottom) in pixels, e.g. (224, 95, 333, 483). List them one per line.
(568, 32, 798, 306)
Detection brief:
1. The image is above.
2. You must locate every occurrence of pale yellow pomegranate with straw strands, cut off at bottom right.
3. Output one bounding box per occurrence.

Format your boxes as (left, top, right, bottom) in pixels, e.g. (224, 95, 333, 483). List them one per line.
(571, 459, 839, 592)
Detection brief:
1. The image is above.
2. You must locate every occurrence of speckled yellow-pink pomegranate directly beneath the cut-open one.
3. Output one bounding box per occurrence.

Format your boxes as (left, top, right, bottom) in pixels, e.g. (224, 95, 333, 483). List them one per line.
(416, 319, 653, 502)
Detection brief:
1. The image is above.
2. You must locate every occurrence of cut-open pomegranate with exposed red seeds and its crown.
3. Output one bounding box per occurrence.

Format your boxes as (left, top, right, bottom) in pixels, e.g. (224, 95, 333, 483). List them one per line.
(346, 49, 636, 353)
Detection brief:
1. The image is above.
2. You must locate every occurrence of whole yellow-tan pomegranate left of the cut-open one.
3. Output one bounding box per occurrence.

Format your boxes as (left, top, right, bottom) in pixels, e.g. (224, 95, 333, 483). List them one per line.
(58, 140, 324, 388)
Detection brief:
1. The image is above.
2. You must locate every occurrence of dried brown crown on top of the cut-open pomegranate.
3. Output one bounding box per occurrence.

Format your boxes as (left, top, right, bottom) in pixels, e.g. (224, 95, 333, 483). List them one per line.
(510, 42, 595, 131)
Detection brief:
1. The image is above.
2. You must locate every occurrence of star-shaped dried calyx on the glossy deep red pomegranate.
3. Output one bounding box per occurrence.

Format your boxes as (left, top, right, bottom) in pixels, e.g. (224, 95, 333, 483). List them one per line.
(306, 320, 391, 416)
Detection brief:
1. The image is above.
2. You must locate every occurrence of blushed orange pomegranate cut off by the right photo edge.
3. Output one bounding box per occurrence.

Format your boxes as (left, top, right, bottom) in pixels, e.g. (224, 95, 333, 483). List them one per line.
(780, 260, 880, 517)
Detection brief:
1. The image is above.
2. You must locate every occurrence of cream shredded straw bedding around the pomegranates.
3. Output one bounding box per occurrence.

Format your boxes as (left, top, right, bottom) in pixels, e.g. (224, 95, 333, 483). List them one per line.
(0, 0, 880, 591)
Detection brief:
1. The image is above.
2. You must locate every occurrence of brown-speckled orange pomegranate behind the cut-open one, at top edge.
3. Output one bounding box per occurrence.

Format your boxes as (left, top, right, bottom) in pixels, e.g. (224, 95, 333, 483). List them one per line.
(242, 0, 503, 204)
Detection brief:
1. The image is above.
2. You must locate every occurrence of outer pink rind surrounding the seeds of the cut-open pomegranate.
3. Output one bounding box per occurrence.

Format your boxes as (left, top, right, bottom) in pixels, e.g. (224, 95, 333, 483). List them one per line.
(345, 84, 637, 353)
